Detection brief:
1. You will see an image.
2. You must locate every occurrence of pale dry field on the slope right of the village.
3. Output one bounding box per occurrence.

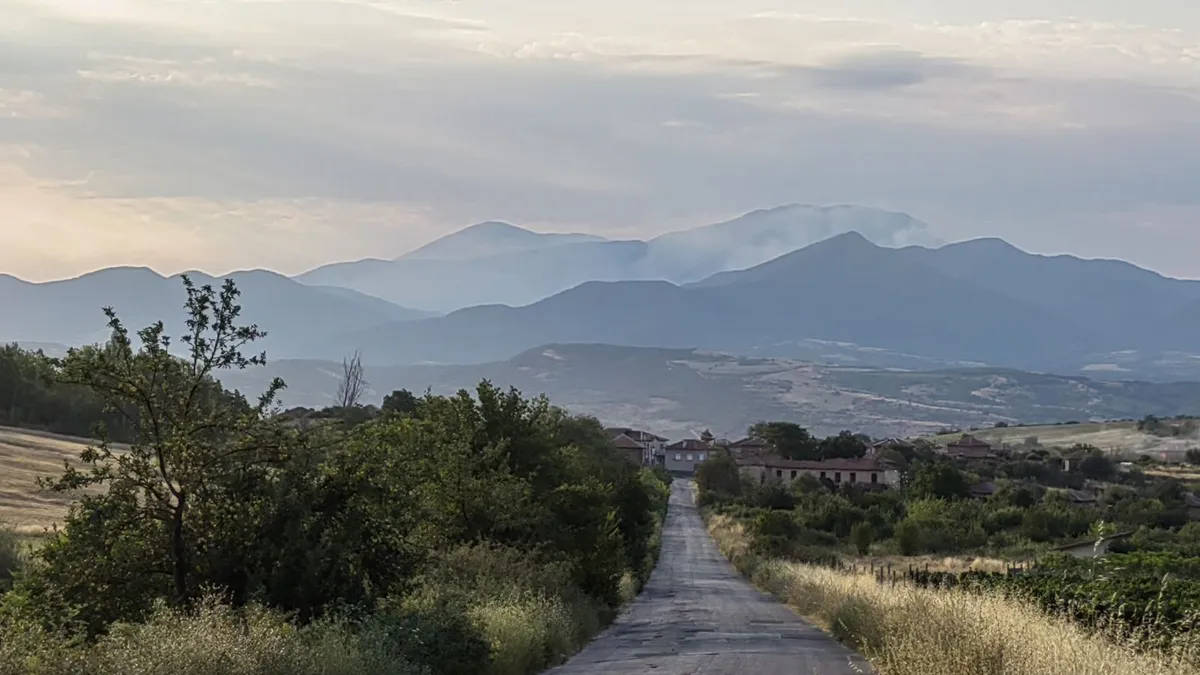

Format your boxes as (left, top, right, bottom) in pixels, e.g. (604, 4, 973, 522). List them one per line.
(928, 422, 1200, 460)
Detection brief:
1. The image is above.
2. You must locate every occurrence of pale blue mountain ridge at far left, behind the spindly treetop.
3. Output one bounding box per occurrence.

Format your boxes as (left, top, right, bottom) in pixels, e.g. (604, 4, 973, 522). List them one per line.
(0, 268, 431, 357)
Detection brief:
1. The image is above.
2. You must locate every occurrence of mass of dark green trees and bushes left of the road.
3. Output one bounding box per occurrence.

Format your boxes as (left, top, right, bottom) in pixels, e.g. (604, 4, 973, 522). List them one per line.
(0, 277, 668, 675)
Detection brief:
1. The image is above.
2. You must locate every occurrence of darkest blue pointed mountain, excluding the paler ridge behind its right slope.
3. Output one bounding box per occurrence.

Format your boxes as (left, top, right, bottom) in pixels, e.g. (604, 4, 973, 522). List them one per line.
(328, 234, 1091, 366)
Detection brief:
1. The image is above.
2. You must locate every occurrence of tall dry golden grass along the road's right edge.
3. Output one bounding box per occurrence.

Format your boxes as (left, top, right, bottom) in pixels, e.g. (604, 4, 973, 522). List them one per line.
(709, 516, 1200, 675)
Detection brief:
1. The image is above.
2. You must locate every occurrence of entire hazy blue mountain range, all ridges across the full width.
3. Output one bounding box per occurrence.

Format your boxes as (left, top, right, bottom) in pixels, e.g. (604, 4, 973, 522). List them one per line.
(7, 207, 1200, 381)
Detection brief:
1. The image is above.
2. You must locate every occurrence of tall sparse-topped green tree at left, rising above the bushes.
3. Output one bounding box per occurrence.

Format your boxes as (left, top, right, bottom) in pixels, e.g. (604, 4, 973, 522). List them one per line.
(21, 276, 302, 631)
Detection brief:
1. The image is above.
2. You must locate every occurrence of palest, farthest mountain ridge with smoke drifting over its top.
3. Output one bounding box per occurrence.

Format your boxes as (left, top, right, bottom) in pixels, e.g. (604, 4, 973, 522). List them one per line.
(296, 204, 941, 312)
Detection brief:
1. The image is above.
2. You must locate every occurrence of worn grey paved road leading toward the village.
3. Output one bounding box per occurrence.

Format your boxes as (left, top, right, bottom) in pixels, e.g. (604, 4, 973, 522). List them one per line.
(550, 479, 871, 675)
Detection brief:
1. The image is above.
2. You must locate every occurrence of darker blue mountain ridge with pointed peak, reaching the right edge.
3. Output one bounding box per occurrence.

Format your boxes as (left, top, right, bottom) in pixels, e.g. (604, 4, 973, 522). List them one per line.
(314, 233, 1200, 375)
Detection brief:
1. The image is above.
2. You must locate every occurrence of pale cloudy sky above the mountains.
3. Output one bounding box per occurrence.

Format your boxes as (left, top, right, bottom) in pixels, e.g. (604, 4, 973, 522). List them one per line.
(0, 0, 1200, 281)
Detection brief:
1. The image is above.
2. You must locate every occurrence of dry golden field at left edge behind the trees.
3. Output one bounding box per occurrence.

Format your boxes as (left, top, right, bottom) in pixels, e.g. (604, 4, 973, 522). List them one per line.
(0, 426, 97, 534)
